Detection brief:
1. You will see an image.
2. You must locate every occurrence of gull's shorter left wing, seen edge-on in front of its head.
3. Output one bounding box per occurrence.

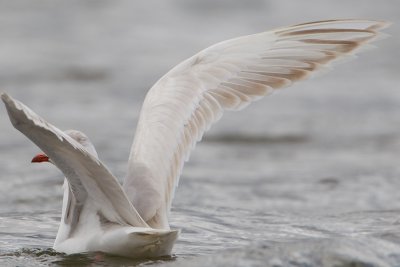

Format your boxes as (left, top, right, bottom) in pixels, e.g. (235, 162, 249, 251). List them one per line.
(1, 94, 148, 227)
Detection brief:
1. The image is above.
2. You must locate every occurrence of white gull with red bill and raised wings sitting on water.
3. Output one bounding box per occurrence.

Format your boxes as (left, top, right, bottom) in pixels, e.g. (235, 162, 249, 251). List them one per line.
(1, 19, 388, 258)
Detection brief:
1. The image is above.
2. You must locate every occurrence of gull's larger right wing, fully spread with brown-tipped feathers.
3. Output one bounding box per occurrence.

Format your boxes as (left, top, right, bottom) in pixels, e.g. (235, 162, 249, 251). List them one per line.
(124, 20, 386, 228)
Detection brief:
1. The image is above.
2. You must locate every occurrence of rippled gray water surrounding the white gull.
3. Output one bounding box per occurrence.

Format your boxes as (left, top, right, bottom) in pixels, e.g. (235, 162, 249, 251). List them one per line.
(0, 0, 400, 266)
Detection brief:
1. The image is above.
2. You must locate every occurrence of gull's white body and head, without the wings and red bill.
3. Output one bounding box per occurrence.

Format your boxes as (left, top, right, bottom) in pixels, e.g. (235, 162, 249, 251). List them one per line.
(50, 130, 178, 257)
